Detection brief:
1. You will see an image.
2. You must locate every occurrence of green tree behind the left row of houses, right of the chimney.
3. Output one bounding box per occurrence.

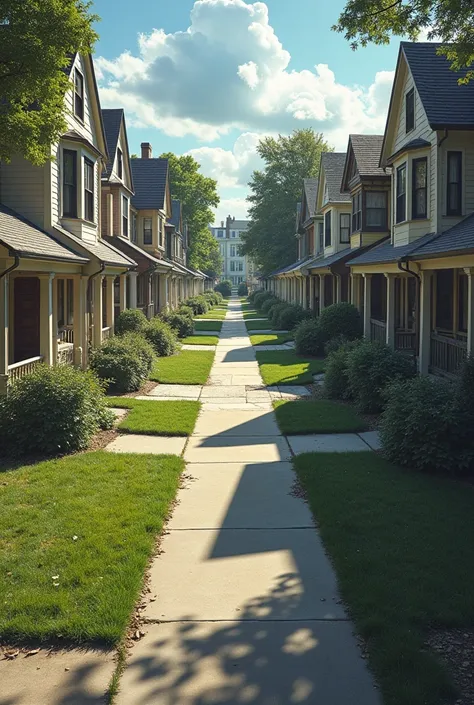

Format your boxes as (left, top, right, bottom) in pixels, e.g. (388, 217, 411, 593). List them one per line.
(161, 152, 221, 276)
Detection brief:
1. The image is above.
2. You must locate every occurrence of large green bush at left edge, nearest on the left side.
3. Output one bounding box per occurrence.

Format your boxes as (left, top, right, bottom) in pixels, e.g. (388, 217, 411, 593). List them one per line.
(0, 365, 113, 455)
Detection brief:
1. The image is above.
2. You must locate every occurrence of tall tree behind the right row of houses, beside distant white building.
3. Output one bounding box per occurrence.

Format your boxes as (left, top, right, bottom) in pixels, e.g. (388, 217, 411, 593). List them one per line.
(242, 129, 332, 274)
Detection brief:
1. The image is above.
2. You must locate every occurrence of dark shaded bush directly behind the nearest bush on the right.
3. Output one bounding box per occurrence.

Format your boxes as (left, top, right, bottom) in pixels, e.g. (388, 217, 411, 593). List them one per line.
(347, 340, 416, 414)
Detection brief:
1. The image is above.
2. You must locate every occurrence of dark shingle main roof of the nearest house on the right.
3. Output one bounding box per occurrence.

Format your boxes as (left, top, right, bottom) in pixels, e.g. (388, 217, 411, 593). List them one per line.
(401, 42, 474, 129)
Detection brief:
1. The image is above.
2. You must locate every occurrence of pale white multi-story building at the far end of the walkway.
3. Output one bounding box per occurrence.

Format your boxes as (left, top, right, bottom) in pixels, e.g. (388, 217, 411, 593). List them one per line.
(211, 215, 255, 285)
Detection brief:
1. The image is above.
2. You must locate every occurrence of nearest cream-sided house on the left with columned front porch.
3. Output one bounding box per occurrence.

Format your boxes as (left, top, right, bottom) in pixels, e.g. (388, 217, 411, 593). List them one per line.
(0, 54, 136, 392)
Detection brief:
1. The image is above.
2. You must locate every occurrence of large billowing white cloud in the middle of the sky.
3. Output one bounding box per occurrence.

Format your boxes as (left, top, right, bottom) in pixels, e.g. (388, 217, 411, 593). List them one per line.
(97, 0, 393, 148)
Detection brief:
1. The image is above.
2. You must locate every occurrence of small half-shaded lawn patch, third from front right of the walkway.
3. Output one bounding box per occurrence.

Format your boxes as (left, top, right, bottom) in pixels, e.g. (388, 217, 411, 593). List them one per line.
(256, 350, 325, 386)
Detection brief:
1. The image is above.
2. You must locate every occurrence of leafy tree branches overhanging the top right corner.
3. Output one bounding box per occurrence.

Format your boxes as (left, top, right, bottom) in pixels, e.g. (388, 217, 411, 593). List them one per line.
(333, 0, 474, 83)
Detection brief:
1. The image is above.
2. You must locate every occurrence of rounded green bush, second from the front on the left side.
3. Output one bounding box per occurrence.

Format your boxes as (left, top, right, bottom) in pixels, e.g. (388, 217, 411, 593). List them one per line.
(90, 333, 155, 394)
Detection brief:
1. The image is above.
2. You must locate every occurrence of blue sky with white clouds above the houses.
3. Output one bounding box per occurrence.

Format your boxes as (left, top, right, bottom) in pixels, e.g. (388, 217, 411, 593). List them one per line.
(94, 0, 404, 223)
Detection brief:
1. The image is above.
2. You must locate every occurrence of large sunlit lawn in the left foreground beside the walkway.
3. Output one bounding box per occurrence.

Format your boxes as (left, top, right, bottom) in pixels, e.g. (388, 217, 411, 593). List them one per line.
(0, 451, 184, 644)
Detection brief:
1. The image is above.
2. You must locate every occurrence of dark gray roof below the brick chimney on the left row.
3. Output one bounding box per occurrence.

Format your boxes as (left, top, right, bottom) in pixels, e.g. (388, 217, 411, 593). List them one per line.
(130, 159, 168, 210)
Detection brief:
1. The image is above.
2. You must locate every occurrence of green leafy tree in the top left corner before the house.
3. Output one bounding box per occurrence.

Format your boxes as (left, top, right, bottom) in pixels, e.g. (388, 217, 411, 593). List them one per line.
(0, 0, 97, 165)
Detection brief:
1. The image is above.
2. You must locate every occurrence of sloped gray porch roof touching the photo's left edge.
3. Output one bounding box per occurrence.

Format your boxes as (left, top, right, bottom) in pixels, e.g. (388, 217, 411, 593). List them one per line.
(0, 203, 89, 264)
